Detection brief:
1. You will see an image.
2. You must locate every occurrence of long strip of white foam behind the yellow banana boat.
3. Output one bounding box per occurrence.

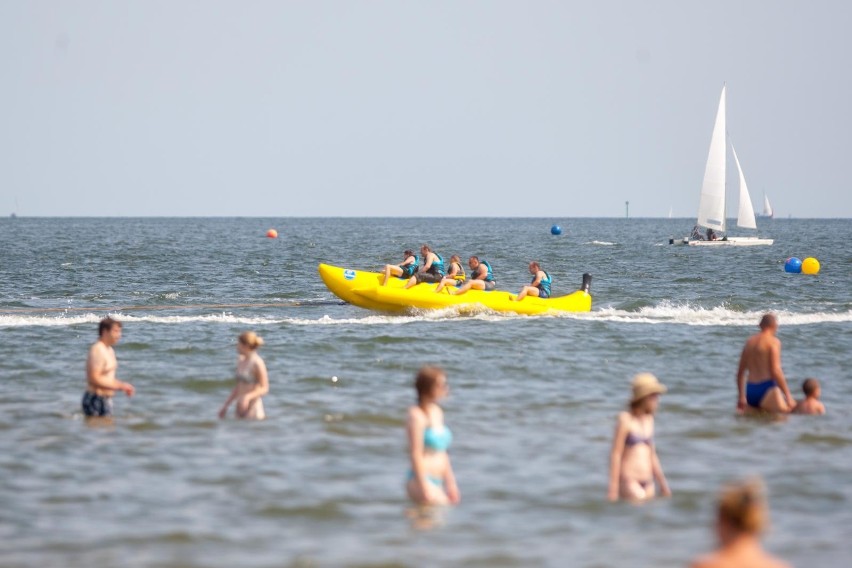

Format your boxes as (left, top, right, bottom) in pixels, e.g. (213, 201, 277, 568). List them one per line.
(0, 301, 852, 327)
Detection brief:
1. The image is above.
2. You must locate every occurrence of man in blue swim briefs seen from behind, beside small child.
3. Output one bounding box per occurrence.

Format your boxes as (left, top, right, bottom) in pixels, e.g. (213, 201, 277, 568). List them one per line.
(737, 314, 796, 413)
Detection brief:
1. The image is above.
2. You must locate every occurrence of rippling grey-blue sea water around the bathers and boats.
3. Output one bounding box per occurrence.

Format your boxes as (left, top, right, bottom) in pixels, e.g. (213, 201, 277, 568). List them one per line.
(0, 218, 852, 567)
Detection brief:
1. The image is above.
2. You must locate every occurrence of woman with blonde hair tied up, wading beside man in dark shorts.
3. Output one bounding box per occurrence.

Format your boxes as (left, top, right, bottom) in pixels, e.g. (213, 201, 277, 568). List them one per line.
(219, 331, 269, 420)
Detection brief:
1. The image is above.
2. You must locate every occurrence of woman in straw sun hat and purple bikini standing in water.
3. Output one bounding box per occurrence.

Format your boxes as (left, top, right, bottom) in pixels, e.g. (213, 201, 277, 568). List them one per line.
(608, 373, 671, 501)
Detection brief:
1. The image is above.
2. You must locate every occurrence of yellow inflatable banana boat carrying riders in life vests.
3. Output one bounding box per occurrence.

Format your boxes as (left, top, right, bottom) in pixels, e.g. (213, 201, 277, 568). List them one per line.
(319, 264, 592, 315)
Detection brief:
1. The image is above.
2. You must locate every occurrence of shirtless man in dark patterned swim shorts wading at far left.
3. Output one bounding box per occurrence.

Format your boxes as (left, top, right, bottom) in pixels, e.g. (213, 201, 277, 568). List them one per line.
(83, 318, 136, 416)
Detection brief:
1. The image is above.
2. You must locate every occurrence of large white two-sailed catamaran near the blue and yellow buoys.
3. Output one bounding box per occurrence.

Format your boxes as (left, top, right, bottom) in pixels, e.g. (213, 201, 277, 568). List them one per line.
(669, 86, 773, 246)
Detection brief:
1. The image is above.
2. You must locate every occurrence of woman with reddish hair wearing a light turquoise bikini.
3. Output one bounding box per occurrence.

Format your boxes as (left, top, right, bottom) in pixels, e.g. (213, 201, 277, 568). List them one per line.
(406, 367, 461, 505)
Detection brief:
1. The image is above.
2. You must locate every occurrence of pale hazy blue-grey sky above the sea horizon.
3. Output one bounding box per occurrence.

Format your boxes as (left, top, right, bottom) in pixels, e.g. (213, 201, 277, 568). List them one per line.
(0, 0, 852, 218)
